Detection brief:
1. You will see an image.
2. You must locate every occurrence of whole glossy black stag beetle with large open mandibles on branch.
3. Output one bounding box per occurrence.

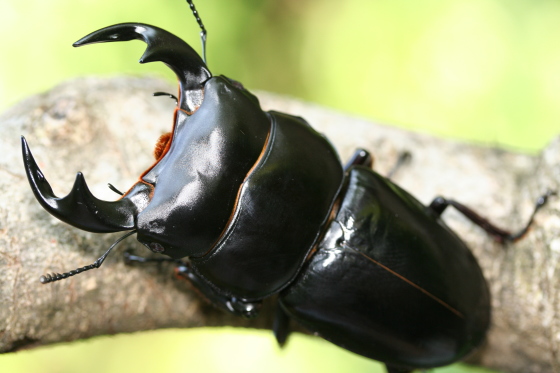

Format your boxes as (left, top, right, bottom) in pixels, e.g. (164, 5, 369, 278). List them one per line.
(22, 0, 551, 372)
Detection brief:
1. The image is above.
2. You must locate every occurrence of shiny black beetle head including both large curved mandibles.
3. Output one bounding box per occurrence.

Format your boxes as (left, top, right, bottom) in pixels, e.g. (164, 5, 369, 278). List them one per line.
(22, 23, 270, 268)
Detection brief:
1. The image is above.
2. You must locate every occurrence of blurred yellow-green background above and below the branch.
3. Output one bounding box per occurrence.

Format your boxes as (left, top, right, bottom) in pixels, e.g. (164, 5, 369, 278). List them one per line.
(0, 0, 560, 373)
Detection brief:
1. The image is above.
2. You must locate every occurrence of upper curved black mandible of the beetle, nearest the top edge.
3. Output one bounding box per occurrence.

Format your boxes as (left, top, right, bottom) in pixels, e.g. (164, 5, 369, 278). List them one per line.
(72, 23, 212, 112)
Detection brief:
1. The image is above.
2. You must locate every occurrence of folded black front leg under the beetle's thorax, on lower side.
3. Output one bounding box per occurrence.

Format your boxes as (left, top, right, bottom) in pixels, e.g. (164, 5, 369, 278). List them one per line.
(176, 263, 262, 319)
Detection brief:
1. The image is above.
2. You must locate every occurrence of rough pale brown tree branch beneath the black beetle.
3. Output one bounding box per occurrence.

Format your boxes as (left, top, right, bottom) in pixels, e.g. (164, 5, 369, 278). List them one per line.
(0, 78, 560, 372)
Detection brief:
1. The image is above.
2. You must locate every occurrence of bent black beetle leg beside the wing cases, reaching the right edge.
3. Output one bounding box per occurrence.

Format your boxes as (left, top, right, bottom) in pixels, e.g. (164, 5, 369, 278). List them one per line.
(429, 190, 556, 243)
